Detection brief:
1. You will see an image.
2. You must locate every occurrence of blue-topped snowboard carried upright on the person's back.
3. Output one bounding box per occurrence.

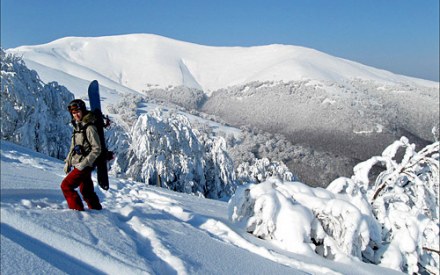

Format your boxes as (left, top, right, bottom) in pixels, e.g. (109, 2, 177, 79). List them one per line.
(88, 80, 109, 190)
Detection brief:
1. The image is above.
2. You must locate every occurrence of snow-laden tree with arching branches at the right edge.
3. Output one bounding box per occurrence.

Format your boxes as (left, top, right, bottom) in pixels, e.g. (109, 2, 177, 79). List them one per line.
(330, 137, 440, 273)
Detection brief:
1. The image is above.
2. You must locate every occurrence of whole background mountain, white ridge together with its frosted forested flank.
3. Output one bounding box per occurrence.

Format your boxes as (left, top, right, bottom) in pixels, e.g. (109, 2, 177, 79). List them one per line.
(7, 34, 440, 185)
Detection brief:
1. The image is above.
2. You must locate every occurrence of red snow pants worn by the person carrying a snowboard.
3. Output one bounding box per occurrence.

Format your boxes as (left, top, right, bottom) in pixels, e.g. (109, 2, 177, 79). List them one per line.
(61, 167, 102, 211)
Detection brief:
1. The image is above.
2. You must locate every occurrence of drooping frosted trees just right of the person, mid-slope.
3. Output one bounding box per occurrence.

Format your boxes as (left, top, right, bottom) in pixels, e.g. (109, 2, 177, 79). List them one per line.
(120, 110, 235, 199)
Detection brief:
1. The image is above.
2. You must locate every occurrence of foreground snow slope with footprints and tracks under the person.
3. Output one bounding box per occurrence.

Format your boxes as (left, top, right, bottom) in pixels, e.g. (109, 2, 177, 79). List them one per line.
(1, 141, 402, 274)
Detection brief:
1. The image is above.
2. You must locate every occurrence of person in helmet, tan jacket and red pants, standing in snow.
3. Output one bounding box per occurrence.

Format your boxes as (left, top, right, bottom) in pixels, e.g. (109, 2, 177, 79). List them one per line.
(61, 99, 102, 211)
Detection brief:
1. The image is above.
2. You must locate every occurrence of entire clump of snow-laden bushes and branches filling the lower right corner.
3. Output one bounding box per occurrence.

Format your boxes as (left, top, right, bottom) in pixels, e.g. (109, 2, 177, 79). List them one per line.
(229, 137, 440, 274)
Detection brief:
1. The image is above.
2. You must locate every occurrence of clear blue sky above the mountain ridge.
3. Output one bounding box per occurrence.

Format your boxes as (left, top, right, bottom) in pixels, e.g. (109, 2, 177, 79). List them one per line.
(1, 0, 439, 81)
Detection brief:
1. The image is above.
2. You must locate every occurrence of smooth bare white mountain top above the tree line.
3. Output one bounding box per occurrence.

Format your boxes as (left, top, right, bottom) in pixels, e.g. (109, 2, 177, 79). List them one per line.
(8, 34, 438, 98)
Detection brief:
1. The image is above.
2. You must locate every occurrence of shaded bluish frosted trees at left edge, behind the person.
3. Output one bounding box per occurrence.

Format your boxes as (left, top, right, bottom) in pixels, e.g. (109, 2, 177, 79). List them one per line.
(1, 51, 73, 159)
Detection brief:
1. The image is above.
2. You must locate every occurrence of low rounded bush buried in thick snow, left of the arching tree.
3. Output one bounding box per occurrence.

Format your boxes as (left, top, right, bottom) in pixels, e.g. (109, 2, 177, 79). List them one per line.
(229, 178, 380, 260)
